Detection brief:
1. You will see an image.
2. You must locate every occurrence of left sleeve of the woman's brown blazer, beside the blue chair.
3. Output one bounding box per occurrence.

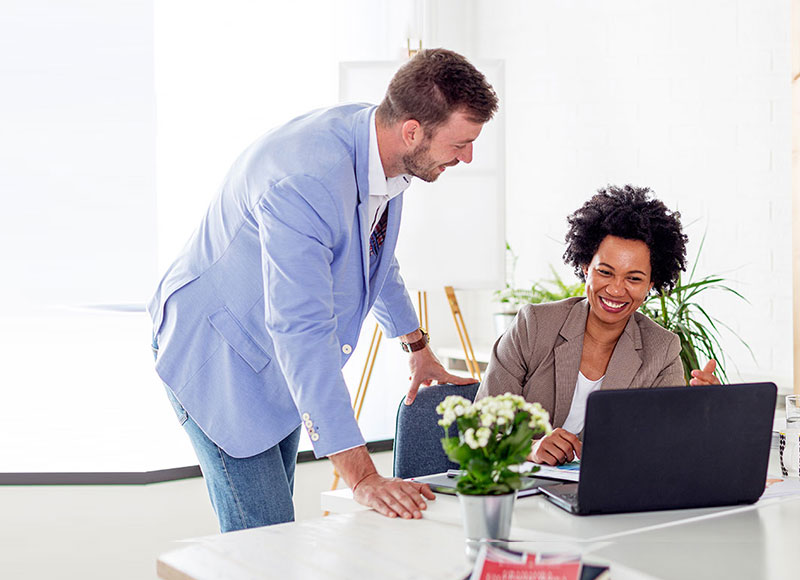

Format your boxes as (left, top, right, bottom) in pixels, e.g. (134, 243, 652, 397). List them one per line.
(475, 307, 537, 400)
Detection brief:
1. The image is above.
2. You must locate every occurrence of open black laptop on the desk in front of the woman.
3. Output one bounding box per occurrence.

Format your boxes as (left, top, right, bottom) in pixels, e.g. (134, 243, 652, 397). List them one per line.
(541, 383, 777, 515)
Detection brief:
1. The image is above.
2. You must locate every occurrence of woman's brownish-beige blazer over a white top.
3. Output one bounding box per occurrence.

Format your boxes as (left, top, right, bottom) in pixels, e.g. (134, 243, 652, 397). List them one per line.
(476, 298, 686, 428)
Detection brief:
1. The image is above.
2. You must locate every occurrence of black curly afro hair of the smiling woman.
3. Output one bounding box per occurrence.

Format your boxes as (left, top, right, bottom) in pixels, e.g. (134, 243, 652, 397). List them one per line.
(564, 185, 687, 292)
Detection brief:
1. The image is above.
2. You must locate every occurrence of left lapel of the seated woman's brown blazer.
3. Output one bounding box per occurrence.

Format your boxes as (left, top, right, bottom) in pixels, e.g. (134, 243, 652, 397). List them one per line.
(552, 300, 589, 426)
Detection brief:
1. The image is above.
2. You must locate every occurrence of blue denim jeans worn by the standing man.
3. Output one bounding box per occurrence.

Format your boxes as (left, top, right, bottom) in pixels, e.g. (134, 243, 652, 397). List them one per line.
(153, 341, 300, 532)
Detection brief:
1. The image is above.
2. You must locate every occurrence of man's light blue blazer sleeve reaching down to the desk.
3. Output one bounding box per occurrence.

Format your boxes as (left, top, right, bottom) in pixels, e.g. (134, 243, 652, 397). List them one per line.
(254, 176, 364, 457)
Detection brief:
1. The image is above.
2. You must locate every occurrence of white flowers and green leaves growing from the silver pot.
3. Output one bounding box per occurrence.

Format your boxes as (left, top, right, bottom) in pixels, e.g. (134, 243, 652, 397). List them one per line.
(436, 393, 552, 495)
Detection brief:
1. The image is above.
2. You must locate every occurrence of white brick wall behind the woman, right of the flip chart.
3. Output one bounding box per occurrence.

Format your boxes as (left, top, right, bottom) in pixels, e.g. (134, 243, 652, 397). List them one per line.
(462, 0, 792, 389)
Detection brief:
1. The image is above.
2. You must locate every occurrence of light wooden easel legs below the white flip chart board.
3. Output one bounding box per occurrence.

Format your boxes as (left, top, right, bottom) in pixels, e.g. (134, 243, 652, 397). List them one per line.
(322, 286, 481, 516)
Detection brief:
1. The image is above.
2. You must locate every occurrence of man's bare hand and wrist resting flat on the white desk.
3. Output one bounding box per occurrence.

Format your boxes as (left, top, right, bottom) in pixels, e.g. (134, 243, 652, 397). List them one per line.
(329, 445, 436, 519)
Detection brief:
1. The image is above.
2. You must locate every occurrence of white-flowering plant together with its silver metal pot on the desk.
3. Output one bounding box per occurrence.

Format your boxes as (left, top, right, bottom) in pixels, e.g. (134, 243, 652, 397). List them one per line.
(436, 393, 551, 559)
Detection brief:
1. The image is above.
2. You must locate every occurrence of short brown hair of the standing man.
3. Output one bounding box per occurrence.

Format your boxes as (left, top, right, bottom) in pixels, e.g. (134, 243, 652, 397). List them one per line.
(377, 48, 497, 130)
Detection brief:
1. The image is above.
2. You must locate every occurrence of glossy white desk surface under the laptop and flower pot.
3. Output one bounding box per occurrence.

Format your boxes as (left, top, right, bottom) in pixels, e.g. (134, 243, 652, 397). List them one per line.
(158, 496, 800, 580)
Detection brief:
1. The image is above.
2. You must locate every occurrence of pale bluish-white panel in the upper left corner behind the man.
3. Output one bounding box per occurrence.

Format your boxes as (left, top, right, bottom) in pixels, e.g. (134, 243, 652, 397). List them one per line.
(0, 0, 156, 310)
